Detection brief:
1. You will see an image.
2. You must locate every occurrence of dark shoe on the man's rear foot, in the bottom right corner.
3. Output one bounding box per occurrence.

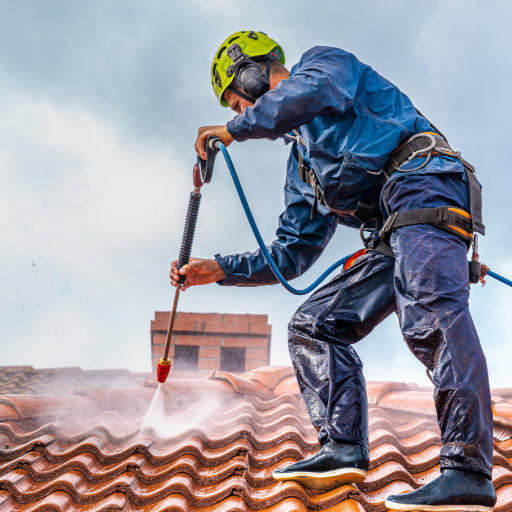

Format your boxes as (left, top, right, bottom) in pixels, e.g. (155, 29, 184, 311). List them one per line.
(386, 469, 496, 512)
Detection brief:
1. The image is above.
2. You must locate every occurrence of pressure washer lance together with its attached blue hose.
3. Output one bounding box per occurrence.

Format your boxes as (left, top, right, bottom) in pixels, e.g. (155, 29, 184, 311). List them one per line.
(157, 136, 512, 382)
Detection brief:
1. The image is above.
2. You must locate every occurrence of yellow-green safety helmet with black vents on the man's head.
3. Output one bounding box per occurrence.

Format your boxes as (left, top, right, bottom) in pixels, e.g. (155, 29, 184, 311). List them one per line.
(211, 30, 285, 107)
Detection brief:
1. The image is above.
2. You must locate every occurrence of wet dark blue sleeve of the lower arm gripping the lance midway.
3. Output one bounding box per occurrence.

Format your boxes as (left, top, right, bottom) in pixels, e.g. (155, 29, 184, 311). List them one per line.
(215, 143, 337, 286)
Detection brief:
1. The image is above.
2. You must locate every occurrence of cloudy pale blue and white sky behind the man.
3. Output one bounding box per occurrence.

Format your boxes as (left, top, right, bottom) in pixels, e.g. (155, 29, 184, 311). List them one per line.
(0, 0, 512, 387)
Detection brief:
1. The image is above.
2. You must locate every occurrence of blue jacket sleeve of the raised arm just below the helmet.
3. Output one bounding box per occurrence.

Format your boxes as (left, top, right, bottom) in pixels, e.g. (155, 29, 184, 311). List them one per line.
(227, 47, 360, 142)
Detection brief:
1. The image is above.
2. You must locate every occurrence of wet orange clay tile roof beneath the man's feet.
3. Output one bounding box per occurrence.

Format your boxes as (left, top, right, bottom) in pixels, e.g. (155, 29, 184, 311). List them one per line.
(0, 367, 512, 512)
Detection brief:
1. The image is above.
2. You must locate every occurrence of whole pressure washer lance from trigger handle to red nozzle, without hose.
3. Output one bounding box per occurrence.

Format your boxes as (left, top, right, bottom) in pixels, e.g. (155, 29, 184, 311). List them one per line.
(156, 137, 220, 384)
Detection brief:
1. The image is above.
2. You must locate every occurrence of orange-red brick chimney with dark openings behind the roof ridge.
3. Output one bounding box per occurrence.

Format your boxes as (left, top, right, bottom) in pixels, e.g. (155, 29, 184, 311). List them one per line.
(151, 311, 272, 379)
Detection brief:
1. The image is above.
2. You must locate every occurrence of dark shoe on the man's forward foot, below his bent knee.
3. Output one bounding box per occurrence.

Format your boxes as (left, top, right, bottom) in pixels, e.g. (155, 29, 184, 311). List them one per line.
(272, 441, 370, 491)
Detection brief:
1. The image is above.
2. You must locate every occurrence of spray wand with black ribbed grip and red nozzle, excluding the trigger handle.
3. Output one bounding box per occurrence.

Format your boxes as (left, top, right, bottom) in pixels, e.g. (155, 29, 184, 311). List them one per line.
(156, 164, 203, 384)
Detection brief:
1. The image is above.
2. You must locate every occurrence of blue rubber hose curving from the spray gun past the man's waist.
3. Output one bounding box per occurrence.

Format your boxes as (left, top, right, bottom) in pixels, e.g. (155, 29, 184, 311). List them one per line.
(217, 142, 512, 295)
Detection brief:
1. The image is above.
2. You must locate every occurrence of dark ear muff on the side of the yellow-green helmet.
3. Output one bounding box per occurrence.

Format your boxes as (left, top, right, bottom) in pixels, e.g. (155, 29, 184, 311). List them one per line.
(227, 43, 276, 102)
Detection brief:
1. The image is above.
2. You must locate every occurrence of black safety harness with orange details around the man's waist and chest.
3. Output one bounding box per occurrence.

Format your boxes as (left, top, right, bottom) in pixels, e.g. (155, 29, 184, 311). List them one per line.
(294, 120, 485, 272)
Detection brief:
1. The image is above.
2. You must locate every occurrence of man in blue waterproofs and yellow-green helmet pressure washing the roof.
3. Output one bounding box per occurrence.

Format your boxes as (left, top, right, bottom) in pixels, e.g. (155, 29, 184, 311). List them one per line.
(171, 31, 496, 511)
